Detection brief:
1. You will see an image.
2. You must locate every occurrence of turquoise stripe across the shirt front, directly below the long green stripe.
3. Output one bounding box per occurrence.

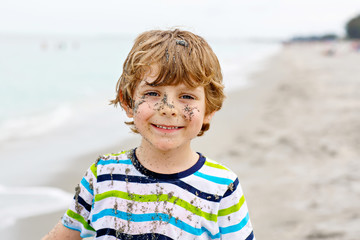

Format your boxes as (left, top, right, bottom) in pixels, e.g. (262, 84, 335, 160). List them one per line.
(92, 209, 220, 239)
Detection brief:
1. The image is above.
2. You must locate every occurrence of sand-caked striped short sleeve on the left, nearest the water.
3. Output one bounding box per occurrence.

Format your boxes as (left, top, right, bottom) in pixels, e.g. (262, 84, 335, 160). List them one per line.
(62, 164, 97, 238)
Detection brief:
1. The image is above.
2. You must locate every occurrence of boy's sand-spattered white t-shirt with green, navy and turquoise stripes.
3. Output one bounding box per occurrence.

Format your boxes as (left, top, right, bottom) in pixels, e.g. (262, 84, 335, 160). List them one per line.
(62, 150, 255, 240)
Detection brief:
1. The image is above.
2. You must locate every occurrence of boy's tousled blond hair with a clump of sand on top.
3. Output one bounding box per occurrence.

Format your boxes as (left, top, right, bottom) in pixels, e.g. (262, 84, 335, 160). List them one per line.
(111, 29, 225, 136)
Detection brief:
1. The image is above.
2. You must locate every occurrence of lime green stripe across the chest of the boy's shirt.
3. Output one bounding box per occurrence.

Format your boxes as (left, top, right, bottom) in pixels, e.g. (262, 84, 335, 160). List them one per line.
(95, 190, 217, 222)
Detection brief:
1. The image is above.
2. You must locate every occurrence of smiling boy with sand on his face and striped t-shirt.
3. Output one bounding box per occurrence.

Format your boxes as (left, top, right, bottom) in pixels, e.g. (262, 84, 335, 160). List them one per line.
(44, 29, 254, 240)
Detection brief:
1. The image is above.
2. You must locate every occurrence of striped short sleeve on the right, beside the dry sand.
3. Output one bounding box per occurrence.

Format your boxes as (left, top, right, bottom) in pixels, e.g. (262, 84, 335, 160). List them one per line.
(218, 178, 255, 240)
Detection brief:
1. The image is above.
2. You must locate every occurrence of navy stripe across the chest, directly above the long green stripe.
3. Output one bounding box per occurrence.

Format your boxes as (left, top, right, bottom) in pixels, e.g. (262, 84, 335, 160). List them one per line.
(97, 174, 222, 202)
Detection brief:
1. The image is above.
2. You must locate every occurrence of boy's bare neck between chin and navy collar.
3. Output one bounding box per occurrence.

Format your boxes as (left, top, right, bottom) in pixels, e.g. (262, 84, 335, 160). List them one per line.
(136, 143, 199, 174)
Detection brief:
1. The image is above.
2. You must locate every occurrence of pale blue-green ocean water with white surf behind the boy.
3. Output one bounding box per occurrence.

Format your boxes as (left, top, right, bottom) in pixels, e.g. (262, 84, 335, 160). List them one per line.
(0, 35, 280, 229)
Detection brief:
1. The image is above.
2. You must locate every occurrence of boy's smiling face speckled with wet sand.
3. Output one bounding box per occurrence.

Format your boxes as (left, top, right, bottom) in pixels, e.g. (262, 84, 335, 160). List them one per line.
(127, 69, 213, 151)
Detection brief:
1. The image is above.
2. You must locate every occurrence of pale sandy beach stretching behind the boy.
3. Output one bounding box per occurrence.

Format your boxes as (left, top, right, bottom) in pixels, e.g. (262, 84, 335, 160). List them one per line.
(7, 43, 360, 240)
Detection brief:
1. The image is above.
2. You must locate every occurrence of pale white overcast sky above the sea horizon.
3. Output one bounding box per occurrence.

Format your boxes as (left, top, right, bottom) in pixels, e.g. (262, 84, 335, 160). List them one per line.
(0, 0, 360, 38)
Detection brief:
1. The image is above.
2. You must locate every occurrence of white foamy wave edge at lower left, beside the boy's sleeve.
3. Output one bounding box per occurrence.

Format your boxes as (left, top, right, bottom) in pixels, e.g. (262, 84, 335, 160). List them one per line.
(0, 185, 73, 229)
